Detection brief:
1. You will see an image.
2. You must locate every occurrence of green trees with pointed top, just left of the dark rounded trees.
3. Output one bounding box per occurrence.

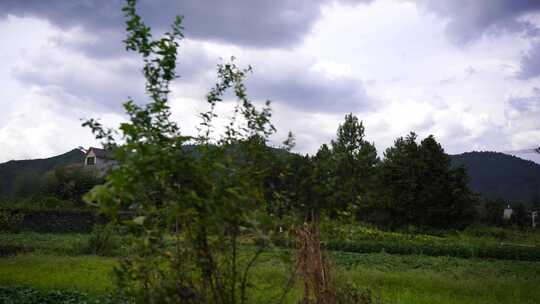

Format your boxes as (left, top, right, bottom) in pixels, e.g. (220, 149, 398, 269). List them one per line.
(267, 114, 379, 220)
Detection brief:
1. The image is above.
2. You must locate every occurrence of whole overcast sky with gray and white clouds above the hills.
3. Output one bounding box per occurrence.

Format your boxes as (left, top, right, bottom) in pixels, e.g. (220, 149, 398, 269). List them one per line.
(0, 0, 540, 162)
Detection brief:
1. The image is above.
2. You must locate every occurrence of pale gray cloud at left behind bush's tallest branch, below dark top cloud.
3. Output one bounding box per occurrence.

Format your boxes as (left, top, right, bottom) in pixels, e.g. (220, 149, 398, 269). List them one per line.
(11, 39, 218, 112)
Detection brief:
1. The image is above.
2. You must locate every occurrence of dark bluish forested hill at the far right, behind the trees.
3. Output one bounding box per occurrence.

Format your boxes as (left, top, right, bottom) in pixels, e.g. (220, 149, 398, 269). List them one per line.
(450, 152, 540, 203)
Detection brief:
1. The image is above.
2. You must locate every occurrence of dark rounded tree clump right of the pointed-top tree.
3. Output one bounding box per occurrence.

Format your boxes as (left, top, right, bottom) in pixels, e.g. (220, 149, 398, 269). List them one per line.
(376, 133, 476, 228)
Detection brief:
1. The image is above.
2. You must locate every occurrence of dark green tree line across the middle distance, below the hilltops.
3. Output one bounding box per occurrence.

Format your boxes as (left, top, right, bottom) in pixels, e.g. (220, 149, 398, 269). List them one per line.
(4, 114, 540, 229)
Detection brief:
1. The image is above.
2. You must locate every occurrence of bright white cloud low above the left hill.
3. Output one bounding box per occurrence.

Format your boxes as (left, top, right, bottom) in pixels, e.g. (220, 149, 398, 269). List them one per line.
(0, 87, 121, 160)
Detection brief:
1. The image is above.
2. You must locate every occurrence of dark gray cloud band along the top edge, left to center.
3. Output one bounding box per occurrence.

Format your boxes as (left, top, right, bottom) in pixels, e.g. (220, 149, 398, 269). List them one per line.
(0, 0, 372, 57)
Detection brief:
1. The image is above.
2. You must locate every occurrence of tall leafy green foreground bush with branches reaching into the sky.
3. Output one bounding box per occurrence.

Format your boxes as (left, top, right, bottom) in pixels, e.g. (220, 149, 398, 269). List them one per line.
(84, 0, 296, 304)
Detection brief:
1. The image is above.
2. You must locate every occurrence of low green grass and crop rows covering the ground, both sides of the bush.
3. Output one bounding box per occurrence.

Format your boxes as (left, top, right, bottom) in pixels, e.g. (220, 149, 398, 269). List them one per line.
(0, 225, 540, 303)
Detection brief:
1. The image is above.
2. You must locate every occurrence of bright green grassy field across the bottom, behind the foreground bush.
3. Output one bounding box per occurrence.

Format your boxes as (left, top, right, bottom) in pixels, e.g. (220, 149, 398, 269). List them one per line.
(0, 233, 540, 304)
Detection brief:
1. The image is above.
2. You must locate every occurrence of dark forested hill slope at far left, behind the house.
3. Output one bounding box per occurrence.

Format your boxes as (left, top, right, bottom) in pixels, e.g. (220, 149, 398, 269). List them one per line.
(0, 149, 84, 198)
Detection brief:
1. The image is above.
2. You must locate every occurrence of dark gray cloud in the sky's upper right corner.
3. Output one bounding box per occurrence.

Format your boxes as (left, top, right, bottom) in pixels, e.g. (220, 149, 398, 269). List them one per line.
(416, 0, 540, 44)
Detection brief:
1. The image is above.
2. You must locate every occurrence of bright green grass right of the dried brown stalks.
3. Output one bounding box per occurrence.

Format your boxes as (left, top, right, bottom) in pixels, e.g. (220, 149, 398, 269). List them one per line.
(336, 254, 540, 303)
